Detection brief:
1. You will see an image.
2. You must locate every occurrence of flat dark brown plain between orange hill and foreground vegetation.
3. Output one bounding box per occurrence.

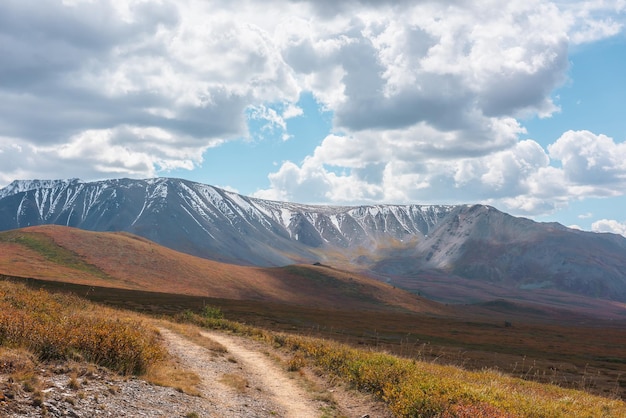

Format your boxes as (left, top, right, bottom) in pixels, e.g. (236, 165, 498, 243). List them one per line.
(7, 274, 626, 398)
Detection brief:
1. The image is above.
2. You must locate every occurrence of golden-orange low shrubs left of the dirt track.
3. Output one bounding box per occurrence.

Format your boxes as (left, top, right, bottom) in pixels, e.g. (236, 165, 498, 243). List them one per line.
(0, 282, 166, 374)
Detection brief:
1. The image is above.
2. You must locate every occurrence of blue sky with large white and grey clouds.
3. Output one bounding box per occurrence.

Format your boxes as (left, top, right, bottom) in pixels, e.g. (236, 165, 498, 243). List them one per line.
(0, 0, 626, 236)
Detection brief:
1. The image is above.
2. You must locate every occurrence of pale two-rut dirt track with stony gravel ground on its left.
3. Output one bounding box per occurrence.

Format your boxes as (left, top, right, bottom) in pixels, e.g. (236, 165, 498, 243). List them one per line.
(0, 324, 392, 418)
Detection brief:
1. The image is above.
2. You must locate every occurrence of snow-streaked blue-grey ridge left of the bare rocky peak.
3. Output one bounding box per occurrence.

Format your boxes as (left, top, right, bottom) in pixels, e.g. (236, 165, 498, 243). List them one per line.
(0, 178, 452, 266)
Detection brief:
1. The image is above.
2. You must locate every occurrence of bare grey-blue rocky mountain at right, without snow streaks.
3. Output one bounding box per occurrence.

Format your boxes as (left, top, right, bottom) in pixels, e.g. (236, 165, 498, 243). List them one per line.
(373, 205, 626, 302)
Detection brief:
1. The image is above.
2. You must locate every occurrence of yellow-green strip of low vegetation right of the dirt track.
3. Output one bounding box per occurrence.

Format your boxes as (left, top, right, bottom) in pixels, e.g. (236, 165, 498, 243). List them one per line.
(178, 312, 626, 418)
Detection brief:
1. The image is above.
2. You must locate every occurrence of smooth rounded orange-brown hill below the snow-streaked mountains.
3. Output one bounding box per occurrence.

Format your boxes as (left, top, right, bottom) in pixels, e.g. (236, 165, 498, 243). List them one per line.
(0, 225, 445, 313)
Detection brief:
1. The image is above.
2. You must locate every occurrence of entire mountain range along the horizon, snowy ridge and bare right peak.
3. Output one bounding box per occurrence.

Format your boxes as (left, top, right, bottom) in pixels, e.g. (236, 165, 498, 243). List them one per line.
(0, 178, 626, 302)
